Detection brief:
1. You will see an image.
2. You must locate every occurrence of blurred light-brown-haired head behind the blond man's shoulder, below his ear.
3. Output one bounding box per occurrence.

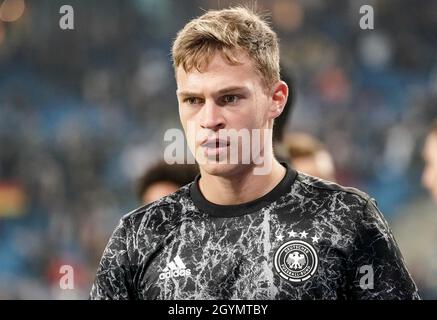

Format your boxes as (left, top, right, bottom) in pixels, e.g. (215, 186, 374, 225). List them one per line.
(283, 132, 336, 182)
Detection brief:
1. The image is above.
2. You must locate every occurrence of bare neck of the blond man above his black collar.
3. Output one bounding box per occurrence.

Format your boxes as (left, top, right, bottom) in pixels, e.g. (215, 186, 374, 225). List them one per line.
(199, 159, 286, 205)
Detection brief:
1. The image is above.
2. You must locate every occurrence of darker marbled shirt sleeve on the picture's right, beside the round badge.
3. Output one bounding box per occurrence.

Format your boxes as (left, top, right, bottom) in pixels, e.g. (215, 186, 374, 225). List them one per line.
(347, 199, 420, 300)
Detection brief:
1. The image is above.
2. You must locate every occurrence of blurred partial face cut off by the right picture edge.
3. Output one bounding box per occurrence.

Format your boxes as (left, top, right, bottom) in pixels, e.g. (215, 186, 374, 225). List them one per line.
(422, 133, 437, 202)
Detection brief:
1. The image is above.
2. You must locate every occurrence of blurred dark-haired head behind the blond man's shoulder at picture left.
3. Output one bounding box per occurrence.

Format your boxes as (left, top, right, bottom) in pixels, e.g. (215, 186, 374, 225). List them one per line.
(137, 160, 198, 204)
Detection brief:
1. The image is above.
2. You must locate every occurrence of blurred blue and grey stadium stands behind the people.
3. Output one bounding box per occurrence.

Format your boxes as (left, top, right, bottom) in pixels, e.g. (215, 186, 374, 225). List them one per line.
(0, 0, 437, 299)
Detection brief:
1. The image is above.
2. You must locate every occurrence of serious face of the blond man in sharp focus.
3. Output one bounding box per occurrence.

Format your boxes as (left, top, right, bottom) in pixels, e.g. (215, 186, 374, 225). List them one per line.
(176, 53, 288, 176)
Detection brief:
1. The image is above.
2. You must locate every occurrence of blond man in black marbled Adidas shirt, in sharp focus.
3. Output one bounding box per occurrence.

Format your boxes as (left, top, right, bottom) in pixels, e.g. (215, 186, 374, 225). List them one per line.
(91, 8, 418, 299)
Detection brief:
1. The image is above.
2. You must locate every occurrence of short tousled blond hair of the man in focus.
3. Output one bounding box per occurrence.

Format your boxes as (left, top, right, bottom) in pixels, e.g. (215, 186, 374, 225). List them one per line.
(172, 7, 280, 88)
